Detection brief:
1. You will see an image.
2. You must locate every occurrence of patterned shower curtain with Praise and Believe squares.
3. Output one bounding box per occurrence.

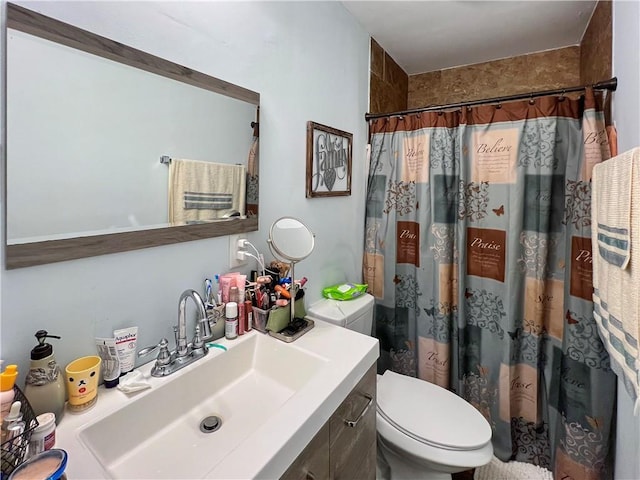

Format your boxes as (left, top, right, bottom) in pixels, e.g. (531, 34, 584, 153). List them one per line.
(363, 90, 616, 480)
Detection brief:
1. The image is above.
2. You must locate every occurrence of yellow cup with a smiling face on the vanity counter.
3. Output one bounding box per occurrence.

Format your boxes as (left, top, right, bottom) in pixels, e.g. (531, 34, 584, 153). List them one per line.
(64, 355, 102, 412)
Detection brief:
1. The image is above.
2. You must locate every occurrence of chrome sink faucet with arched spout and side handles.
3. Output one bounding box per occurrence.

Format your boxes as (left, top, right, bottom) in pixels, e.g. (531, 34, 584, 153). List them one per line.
(138, 289, 216, 377)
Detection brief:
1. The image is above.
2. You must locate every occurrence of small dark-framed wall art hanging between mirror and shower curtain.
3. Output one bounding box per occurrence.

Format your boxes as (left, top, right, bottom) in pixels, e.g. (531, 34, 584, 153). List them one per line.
(307, 121, 353, 198)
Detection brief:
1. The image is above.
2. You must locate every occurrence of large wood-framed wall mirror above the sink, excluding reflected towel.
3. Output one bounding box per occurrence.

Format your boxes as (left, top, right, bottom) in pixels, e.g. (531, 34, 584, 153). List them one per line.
(4, 3, 260, 269)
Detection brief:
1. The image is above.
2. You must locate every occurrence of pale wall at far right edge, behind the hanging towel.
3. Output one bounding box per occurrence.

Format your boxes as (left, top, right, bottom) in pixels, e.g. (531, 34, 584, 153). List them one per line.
(613, 0, 640, 480)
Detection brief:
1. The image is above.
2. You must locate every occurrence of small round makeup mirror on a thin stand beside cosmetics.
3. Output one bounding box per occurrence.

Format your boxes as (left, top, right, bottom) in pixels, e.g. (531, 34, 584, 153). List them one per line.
(267, 217, 315, 334)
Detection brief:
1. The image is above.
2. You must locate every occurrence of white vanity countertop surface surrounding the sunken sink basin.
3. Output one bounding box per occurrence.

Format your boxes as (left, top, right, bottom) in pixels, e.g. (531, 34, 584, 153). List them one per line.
(55, 320, 379, 479)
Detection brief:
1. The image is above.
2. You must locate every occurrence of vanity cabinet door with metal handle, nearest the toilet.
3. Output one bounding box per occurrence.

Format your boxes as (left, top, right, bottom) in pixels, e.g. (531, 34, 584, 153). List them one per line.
(329, 365, 377, 480)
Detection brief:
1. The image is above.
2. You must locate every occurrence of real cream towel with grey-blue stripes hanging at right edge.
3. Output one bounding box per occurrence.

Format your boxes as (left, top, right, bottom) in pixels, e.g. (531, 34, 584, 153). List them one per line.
(591, 148, 640, 413)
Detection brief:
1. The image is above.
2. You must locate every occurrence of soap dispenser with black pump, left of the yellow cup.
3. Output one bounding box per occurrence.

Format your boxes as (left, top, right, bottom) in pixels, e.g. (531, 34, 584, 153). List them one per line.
(24, 330, 66, 423)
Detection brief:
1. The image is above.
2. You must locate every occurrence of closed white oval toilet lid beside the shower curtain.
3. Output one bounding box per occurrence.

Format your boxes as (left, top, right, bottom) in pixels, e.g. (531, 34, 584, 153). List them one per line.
(377, 370, 491, 450)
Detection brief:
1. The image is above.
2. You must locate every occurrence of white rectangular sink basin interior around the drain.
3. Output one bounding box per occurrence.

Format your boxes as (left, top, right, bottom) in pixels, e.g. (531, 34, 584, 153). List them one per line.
(80, 335, 327, 479)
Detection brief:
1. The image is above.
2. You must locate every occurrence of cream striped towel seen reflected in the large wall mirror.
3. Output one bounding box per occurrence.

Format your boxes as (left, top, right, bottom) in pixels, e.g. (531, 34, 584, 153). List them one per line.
(169, 159, 247, 225)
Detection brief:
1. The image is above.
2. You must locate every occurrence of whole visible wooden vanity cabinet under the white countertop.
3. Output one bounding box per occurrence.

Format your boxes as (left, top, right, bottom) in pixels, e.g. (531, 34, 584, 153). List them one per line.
(280, 365, 376, 480)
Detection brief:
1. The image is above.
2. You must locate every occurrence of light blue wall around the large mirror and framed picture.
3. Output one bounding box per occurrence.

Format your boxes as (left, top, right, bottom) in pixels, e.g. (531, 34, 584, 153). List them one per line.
(0, 1, 369, 381)
